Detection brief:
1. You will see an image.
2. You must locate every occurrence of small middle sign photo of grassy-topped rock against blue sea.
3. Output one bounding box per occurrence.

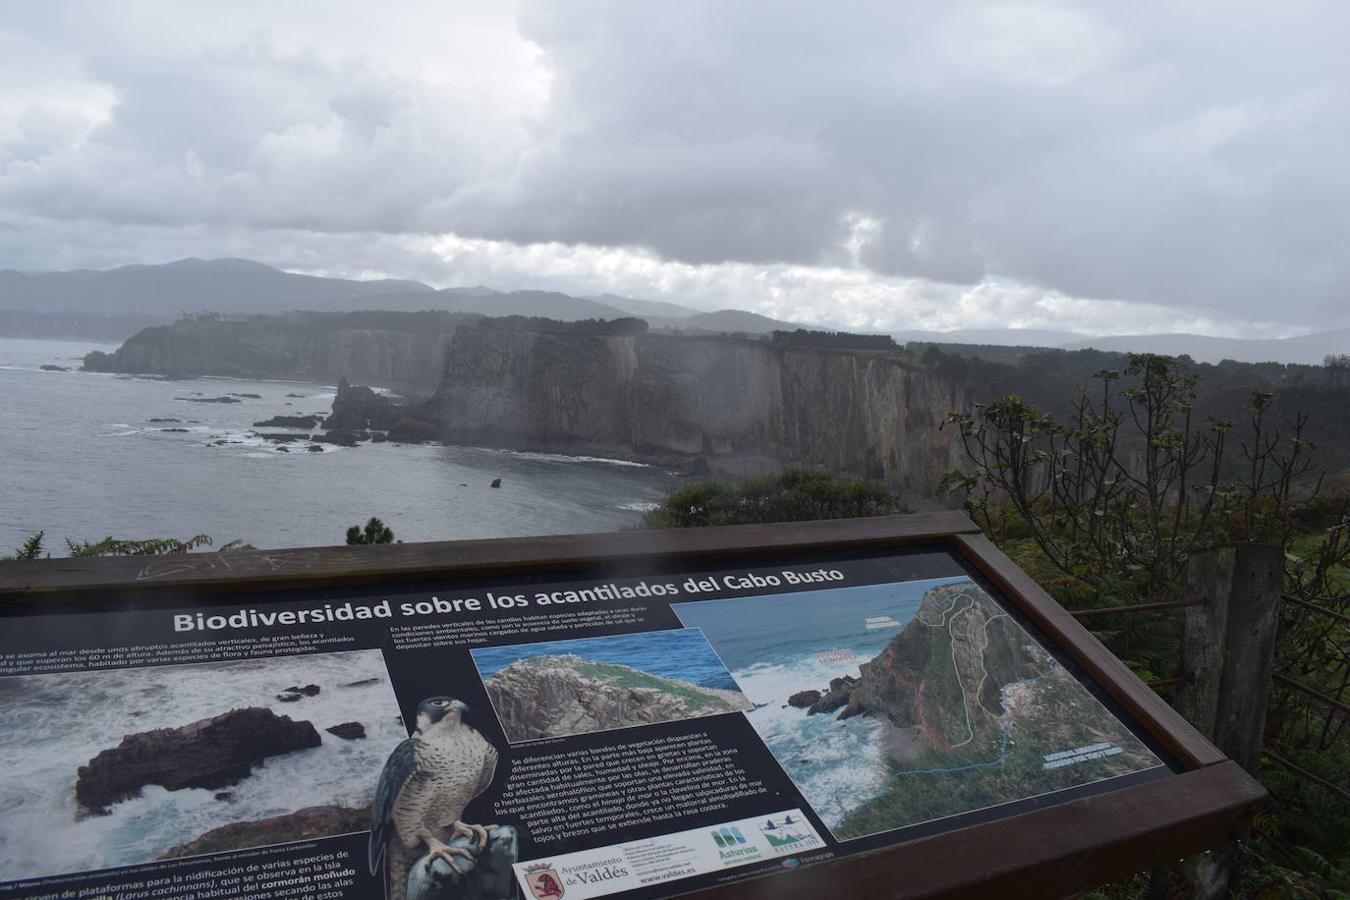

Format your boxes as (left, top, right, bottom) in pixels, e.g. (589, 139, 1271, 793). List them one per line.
(473, 629, 751, 743)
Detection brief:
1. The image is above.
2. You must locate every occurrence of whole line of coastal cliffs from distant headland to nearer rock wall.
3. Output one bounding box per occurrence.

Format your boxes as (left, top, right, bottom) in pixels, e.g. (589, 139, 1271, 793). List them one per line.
(84, 312, 967, 497)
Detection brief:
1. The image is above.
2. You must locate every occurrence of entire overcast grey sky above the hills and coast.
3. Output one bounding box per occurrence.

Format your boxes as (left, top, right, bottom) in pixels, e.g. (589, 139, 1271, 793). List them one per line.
(0, 0, 1350, 336)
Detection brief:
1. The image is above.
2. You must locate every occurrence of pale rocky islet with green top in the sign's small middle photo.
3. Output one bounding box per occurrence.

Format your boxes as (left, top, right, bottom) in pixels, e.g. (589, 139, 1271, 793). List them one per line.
(486, 654, 751, 741)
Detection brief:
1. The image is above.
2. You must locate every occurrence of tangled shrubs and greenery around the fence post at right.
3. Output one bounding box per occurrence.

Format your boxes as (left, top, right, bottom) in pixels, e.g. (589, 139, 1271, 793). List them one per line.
(945, 355, 1350, 899)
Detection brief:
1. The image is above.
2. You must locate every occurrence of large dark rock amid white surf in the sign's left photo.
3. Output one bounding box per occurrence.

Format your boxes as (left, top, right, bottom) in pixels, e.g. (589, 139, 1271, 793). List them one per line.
(76, 707, 320, 815)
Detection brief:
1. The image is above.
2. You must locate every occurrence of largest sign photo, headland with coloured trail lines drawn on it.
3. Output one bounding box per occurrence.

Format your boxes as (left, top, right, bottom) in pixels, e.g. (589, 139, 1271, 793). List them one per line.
(674, 576, 1162, 839)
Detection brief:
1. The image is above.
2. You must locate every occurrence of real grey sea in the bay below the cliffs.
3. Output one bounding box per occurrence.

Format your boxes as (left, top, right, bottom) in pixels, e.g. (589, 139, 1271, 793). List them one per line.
(0, 337, 683, 556)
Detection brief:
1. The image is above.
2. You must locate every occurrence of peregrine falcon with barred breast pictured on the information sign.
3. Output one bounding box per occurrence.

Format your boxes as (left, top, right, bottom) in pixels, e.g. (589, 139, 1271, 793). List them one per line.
(370, 696, 497, 900)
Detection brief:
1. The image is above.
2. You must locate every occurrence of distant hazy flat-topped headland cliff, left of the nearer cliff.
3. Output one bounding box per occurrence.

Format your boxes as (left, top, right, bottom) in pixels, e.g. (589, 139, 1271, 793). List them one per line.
(85, 313, 477, 394)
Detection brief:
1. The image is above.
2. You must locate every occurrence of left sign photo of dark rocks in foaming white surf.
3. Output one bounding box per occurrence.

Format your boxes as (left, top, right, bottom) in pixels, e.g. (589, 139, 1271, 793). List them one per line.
(0, 650, 406, 881)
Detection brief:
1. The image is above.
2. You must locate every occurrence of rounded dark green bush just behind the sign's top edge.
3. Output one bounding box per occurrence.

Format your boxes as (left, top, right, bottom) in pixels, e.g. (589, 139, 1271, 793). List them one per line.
(643, 468, 910, 528)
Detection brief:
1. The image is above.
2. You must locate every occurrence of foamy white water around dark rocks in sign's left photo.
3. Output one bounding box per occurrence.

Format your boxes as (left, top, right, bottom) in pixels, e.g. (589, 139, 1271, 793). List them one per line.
(0, 650, 408, 880)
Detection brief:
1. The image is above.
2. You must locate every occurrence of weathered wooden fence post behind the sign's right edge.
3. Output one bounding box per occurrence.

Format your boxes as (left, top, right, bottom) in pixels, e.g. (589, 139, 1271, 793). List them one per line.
(1156, 544, 1284, 899)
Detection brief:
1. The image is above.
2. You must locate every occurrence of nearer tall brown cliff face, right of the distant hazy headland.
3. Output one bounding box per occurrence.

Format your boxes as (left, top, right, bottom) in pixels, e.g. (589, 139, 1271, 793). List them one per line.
(421, 328, 965, 494)
